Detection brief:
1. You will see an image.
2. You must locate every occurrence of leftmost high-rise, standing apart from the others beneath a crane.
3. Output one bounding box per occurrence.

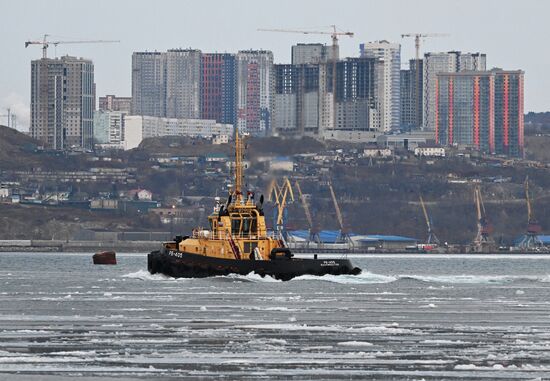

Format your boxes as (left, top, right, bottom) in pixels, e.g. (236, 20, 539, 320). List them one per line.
(30, 56, 95, 149)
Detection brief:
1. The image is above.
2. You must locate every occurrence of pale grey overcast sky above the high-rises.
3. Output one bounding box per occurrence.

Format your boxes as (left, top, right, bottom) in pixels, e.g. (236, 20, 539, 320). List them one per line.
(0, 0, 550, 130)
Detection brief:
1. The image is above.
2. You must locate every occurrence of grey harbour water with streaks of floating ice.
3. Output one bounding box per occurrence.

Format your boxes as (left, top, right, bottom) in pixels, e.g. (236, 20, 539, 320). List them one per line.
(0, 253, 550, 380)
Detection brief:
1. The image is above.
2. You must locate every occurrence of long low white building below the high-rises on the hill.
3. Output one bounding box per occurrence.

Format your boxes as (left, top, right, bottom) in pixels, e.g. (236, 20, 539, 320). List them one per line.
(124, 115, 233, 150)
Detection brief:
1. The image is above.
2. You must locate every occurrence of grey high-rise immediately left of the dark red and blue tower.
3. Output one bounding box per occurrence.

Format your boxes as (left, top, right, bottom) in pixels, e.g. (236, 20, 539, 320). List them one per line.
(166, 49, 205, 119)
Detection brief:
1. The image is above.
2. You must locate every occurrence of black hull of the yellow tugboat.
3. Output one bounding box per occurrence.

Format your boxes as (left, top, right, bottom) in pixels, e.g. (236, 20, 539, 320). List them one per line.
(147, 251, 361, 280)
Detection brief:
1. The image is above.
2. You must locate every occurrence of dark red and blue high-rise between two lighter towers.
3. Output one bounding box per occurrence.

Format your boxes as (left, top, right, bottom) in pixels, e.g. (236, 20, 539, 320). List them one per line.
(201, 53, 237, 124)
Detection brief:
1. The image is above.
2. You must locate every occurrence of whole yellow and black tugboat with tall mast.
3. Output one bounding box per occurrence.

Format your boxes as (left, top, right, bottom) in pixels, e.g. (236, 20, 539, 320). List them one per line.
(147, 133, 361, 280)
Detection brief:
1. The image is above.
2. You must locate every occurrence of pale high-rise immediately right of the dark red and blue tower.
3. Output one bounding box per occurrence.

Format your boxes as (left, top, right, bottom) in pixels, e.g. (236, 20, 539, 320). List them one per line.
(237, 50, 274, 136)
